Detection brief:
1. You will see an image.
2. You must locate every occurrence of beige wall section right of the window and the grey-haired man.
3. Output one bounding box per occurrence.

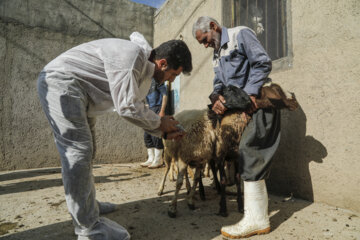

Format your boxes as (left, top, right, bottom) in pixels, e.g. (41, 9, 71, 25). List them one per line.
(269, 0, 360, 212)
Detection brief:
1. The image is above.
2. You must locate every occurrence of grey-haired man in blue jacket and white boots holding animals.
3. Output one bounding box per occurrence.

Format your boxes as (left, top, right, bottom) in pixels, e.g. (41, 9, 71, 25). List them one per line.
(192, 16, 280, 239)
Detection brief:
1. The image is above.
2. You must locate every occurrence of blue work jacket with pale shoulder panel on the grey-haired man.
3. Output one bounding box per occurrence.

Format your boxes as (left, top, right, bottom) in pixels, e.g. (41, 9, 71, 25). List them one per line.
(213, 26, 271, 95)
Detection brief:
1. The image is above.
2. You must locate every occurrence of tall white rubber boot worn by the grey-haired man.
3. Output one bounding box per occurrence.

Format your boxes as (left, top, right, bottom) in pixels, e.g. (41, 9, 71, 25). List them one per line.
(221, 180, 270, 239)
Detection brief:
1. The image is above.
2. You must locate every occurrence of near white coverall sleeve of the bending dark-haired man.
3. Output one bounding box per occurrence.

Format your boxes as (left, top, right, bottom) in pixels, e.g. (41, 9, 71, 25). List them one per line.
(105, 48, 162, 137)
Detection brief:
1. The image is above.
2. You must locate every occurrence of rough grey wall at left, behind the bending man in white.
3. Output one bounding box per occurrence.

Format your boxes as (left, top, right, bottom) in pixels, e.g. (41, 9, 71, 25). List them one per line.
(0, 0, 155, 170)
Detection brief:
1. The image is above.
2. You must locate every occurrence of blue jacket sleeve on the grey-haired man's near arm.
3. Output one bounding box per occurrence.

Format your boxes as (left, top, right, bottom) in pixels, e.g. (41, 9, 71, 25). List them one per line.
(237, 29, 272, 95)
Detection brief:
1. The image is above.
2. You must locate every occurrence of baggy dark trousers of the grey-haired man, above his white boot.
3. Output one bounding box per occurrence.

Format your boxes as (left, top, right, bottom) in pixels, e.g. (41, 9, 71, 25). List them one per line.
(238, 109, 280, 181)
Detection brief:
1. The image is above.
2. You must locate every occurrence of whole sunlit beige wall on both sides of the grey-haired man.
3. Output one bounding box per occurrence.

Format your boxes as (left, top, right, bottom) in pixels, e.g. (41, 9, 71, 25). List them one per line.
(154, 0, 360, 212)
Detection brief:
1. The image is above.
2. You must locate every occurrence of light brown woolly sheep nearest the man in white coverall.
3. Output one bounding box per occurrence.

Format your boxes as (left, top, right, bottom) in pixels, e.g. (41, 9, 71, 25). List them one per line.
(158, 110, 216, 217)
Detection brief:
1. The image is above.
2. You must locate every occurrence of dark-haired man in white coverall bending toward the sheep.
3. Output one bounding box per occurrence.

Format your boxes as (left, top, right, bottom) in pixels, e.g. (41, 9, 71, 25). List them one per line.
(37, 33, 192, 240)
